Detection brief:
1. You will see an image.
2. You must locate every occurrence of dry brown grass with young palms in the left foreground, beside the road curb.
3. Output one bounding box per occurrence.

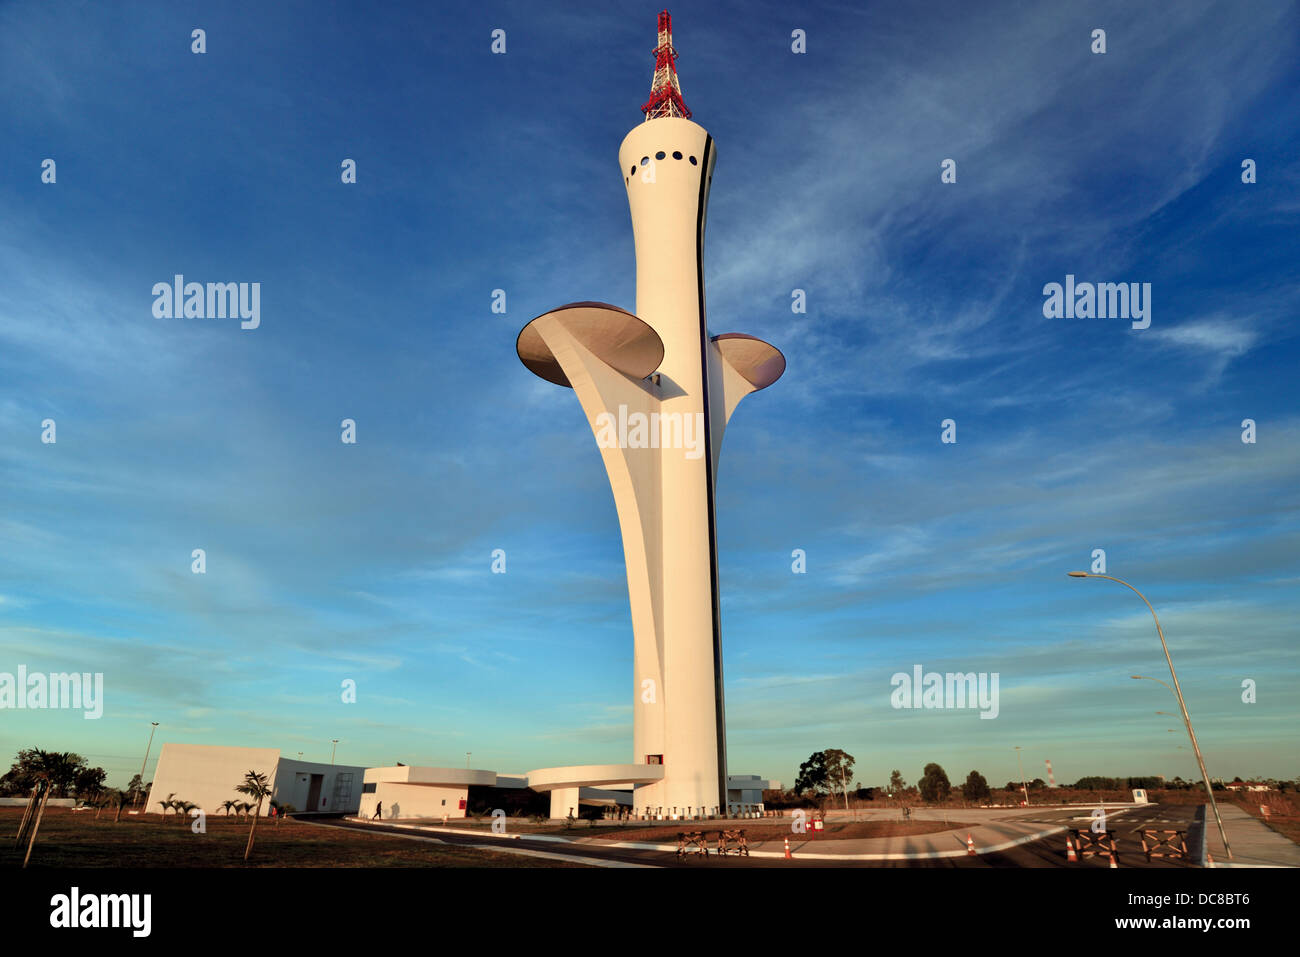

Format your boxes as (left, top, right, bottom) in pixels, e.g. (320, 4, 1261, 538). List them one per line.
(0, 807, 582, 870)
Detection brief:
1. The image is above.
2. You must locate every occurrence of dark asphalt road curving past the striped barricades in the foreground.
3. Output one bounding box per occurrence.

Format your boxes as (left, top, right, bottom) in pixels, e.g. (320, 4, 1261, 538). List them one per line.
(317, 805, 1205, 869)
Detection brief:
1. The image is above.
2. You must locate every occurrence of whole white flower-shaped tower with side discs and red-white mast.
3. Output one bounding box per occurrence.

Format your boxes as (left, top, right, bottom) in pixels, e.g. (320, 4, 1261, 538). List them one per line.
(516, 10, 785, 818)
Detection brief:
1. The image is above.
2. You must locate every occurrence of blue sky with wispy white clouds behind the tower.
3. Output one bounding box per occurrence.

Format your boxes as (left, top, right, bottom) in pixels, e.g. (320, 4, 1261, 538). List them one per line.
(0, 1, 1300, 784)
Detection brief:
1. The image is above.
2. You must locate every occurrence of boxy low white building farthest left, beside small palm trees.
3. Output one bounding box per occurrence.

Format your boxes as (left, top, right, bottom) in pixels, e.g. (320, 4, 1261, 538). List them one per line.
(146, 741, 365, 815)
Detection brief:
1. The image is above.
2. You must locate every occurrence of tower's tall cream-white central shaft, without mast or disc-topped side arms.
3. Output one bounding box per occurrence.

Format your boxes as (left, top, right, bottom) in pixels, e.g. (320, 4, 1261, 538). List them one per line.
(619, 117, 727, 814)
